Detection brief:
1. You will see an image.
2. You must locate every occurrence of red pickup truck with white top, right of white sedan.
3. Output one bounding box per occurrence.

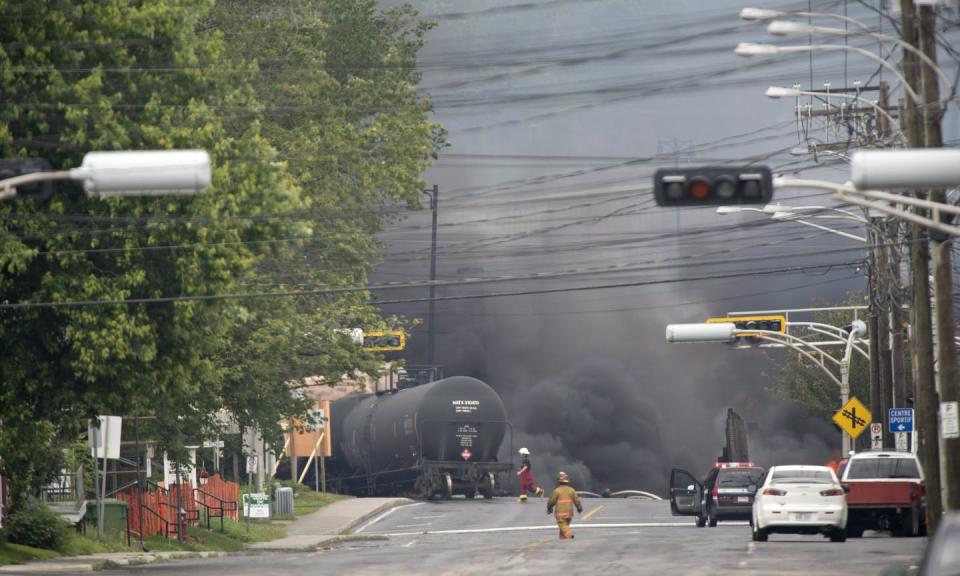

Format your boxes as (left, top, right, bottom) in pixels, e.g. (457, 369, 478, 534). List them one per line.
(840, 451, 926, 538)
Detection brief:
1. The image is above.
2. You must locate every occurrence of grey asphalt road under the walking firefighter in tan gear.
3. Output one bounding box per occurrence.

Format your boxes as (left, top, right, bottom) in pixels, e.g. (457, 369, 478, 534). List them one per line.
(95, 498, 926, 576)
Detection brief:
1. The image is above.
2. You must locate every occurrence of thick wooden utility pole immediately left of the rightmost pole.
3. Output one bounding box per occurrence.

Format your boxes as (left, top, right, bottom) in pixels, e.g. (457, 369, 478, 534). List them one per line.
(900, 0, 943, 534)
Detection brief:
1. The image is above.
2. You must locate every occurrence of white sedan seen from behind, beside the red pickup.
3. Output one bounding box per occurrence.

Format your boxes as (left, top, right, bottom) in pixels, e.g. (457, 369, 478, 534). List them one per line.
(753, 466, 847, 542)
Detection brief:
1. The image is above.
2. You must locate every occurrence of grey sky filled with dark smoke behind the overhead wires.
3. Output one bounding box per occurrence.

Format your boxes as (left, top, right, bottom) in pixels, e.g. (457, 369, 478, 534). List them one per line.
(374, 0, 960, 494)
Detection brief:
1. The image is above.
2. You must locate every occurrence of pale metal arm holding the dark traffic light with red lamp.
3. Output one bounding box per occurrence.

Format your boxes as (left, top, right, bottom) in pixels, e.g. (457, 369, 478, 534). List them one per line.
(773, 176, 960, 236)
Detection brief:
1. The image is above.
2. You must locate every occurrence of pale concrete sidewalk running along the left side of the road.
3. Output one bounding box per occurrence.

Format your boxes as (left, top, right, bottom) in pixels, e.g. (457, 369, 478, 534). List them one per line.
(0, 498, 413, 574)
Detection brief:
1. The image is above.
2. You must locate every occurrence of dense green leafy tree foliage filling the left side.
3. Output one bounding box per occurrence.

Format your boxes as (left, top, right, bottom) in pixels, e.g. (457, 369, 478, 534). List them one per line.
(0, 0, 442, 504)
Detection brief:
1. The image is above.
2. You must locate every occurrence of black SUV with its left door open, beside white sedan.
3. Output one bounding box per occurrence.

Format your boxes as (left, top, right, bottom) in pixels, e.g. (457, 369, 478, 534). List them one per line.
(670, 462, 766, 528)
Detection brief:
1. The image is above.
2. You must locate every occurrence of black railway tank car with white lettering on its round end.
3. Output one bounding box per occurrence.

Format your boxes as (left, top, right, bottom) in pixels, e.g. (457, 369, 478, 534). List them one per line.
(329, 376, 512, 498)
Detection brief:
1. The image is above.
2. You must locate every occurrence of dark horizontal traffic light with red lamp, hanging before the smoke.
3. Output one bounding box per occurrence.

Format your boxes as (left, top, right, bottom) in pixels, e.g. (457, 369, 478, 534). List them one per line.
(653, 166, 773, 206)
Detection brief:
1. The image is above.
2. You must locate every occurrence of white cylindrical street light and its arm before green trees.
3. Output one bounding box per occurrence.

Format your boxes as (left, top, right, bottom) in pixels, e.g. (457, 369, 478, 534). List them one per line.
(0, 150, 211, 200)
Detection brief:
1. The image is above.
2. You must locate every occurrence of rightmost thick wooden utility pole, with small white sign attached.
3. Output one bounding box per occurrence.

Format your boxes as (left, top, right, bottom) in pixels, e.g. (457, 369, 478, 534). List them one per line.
(917, 6, 960, 510)
